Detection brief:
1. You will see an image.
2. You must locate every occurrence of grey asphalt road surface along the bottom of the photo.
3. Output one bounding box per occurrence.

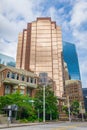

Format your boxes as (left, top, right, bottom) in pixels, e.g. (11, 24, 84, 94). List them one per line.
(0, 122, 87, 130)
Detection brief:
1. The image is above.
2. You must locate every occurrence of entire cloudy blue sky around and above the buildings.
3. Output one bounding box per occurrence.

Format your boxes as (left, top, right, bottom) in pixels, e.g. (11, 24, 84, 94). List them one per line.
(0, 0, 87, 87)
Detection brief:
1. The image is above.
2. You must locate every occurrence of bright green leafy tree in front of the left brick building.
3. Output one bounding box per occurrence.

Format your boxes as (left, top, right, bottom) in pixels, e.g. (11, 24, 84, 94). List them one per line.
(0, 92, 35, 119)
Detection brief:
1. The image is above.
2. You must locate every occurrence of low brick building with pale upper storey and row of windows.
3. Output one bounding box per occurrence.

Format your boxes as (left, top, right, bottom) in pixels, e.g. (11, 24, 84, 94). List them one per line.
(0, 64, 37, 96)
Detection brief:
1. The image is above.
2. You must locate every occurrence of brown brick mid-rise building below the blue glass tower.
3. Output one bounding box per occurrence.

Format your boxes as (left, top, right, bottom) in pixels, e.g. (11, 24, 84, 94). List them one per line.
(65, 80, 84, 106)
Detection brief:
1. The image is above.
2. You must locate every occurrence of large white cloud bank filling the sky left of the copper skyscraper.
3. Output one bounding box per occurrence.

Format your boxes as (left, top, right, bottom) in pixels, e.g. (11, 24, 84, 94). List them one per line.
(0, 0, 43, 58)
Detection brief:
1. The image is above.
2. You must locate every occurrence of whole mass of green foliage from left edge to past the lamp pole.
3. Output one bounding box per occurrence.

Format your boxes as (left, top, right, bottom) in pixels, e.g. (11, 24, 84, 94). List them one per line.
(0, 86, 58, 122)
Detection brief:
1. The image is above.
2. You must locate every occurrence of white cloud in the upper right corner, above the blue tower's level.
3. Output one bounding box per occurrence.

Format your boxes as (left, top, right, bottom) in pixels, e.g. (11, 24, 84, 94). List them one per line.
(70, 0, 87, 49)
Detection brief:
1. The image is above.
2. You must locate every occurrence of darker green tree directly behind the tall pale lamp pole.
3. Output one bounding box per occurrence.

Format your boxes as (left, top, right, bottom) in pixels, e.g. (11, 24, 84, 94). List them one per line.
(35, 86, 58, 120)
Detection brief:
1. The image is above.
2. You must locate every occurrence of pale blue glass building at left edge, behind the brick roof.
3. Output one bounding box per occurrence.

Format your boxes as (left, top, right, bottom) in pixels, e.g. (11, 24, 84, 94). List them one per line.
(0, 54, 16, 67)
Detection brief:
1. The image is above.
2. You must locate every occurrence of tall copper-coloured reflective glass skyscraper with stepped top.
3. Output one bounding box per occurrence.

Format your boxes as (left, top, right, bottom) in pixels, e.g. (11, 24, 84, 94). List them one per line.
(16, 18, 63, 97)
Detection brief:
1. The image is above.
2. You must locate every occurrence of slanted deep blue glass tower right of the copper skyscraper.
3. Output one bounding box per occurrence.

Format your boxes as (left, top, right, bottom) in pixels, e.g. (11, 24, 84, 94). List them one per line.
(63, 41, 81, 80)
